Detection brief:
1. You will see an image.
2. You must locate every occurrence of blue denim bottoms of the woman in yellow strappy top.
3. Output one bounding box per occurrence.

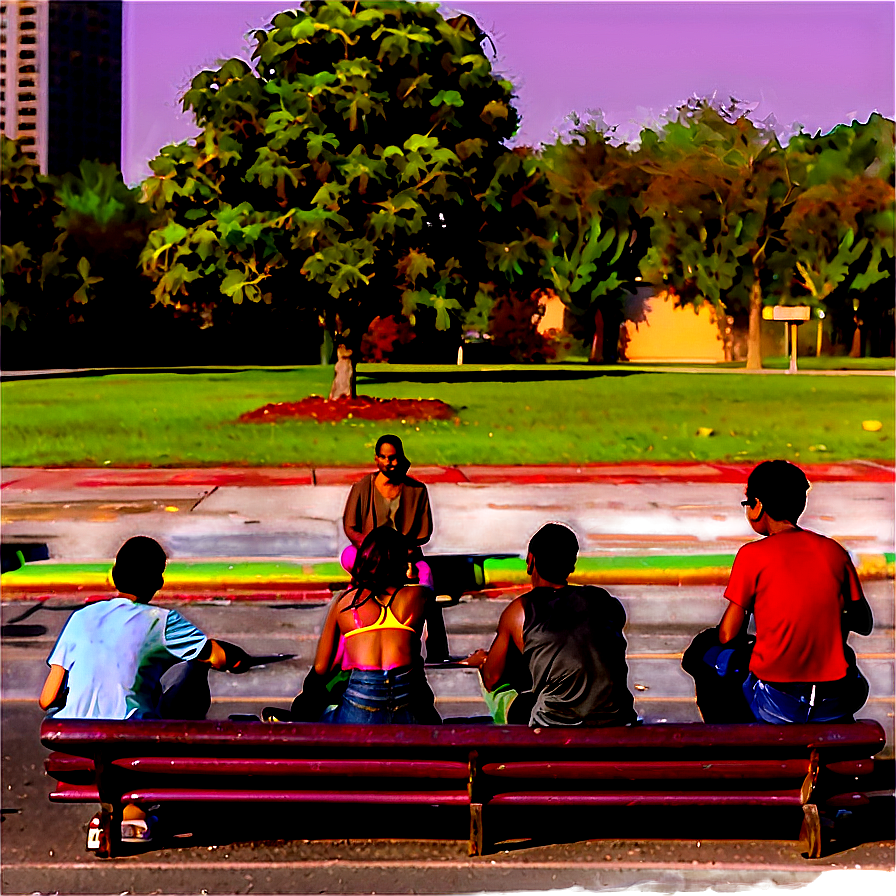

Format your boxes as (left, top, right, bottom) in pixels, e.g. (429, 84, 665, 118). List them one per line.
(322, 666, 421, 725)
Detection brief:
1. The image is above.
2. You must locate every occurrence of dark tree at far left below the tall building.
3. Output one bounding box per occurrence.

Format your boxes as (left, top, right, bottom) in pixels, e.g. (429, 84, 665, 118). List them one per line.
(0, 137, 150, 366)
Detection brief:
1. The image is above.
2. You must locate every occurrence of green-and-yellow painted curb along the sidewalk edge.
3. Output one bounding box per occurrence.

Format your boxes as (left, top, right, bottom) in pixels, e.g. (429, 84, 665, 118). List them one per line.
(0, 552, 896, 601)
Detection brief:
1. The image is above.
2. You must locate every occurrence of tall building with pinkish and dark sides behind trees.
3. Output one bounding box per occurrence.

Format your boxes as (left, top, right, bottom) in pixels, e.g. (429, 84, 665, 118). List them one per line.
(0, 0, 122, 174)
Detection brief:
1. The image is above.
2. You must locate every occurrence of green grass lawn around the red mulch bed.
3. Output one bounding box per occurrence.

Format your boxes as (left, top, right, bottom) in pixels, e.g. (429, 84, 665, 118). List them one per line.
(0, 364, 894, 466)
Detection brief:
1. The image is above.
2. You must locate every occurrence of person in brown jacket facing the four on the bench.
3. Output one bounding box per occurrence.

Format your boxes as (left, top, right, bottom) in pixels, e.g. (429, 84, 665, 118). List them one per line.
(340, 435, 449, 663)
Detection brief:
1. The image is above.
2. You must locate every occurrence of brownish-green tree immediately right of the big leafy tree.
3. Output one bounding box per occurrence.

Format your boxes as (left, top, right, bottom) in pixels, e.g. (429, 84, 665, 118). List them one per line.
(468, 115, 650, 362)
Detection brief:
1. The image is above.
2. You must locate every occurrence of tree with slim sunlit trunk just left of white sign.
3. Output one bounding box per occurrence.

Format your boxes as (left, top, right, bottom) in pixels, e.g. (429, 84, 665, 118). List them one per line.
(639, 99, 799, 369)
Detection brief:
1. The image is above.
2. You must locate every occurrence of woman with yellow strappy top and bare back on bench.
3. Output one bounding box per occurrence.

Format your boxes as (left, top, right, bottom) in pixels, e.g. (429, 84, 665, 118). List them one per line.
(314, 526, 436, 725)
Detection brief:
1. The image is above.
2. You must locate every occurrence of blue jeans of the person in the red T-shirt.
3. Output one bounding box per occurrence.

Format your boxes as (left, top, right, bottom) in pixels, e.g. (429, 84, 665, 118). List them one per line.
(744, 666, 868, 725)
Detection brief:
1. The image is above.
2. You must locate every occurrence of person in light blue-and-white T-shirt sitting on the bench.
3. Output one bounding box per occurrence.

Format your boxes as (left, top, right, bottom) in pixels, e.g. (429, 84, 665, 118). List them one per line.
(38, 535, 250, 842)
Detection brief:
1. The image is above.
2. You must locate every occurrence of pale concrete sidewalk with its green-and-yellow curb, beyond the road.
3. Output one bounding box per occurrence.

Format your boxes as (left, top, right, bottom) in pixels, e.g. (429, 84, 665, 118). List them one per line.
(0, 461, 896, 600)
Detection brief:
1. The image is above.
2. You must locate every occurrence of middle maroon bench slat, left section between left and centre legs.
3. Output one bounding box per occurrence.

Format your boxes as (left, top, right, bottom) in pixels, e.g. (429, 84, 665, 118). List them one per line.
(112, 756, 469, 780)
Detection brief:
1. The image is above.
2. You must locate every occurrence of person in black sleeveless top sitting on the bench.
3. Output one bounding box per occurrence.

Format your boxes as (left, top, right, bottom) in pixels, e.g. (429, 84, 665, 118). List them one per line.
(465, 523, 637, 727)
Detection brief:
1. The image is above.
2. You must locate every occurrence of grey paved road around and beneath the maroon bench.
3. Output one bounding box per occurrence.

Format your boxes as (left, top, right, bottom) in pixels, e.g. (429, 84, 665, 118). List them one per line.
(0, 582, 894, 893)
